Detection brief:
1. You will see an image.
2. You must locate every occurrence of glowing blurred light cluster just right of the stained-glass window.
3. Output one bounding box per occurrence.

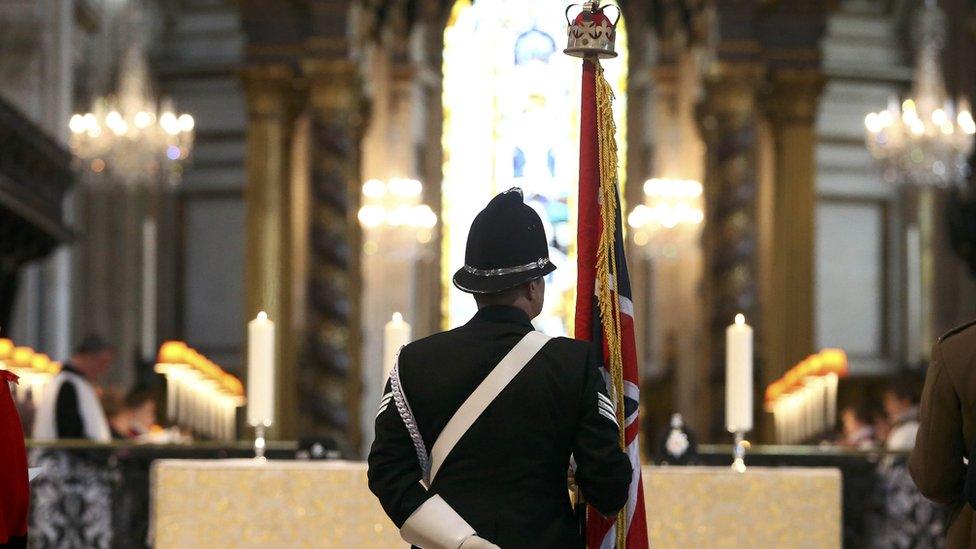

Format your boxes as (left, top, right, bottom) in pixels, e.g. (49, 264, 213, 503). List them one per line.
(627, 178, 705, 255)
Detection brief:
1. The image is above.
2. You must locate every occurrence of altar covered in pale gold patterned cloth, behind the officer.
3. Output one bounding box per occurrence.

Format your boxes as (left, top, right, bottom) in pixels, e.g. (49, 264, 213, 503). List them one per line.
(150, 459, 841, 549)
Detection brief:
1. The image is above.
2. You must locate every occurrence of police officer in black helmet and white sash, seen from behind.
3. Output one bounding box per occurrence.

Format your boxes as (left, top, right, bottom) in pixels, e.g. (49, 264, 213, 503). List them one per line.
(369, 189, 632, 549)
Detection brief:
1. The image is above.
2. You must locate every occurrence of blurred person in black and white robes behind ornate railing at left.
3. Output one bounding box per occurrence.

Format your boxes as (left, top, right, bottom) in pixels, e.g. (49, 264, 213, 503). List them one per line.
(30, 335, 115, 549)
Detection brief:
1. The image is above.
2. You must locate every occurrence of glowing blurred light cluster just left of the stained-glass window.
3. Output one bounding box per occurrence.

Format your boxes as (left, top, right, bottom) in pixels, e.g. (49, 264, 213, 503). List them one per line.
(359, 178, 437, 249)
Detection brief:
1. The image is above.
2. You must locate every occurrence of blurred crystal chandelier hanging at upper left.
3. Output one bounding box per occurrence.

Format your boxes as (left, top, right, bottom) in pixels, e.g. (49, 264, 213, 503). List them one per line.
(68, 40, 194, 185)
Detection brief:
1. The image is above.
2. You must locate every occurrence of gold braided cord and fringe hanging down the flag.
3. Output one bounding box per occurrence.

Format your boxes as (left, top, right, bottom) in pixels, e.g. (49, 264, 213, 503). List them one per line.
(589, 59, 627, 549)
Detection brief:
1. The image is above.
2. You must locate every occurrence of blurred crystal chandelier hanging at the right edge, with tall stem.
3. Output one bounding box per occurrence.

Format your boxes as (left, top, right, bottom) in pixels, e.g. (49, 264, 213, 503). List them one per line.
(864, 0, 976, 187)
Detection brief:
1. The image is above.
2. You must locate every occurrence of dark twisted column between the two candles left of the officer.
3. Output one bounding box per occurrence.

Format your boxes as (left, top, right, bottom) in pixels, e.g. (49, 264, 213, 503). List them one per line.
(299, 59, 363, 449)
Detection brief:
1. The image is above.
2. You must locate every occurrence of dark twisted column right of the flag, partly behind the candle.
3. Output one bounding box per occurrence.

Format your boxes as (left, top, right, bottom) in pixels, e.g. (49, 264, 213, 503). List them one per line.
(697, 62, 764, 440)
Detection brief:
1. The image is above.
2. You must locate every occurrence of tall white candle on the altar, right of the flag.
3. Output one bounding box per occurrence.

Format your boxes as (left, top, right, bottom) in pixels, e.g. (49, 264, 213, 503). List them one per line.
(725, 315, 752, 433)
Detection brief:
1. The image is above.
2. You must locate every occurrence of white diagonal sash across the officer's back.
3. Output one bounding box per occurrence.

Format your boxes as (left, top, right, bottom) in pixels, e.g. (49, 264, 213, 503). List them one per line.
(430, 331, 550, 482)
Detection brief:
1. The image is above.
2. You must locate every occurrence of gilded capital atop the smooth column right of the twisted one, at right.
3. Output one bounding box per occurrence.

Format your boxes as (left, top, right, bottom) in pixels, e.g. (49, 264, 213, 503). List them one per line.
(762, 68, 826, 124)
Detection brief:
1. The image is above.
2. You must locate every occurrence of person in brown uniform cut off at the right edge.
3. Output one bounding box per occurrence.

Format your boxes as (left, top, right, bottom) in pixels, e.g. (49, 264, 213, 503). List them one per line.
(909, 321, 976, 549)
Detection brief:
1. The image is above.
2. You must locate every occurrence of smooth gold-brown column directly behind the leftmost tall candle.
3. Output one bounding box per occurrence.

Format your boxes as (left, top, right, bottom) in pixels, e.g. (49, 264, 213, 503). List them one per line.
(242, 65, 298, 438)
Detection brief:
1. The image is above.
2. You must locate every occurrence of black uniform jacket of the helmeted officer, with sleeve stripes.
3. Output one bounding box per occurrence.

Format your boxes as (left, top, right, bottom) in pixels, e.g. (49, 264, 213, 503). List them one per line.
(369, 307, 632, 549)
